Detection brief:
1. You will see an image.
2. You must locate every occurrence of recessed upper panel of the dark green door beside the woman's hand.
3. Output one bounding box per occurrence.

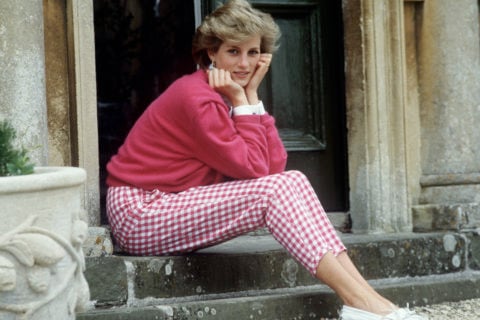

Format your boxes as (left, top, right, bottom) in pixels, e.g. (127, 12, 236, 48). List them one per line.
(260, 12, 325, 151)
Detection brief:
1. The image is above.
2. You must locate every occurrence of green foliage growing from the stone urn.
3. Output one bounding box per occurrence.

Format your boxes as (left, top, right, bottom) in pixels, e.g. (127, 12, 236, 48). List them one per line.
(0, 121, 34, 176)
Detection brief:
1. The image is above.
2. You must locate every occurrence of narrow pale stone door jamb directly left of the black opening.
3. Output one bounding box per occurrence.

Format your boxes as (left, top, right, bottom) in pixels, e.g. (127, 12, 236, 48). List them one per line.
(66, 0, 100, 226)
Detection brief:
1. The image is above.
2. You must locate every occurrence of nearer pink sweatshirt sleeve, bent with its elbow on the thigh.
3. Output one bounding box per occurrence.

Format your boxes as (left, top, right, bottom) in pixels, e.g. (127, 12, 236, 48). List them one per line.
(190, 102, 278, 179)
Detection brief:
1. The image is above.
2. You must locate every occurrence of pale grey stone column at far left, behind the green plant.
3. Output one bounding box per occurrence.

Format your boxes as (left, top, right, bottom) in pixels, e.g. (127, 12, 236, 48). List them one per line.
(0, 0, 48, 165)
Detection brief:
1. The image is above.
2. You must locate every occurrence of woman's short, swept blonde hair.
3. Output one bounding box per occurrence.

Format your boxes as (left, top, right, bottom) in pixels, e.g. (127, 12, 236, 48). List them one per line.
(192, 0, 280, 68)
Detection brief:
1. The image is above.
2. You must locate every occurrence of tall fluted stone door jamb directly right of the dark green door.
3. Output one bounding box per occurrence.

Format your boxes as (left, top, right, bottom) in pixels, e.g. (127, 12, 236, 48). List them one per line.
(343, 0, 412, 233)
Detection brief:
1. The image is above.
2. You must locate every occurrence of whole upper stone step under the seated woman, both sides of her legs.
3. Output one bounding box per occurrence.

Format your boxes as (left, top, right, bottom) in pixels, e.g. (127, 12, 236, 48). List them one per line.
(85, 233, 480, 308)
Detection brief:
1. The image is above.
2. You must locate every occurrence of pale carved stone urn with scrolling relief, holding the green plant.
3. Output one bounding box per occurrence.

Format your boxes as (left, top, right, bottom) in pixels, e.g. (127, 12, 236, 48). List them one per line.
(0, 167, 90, 320)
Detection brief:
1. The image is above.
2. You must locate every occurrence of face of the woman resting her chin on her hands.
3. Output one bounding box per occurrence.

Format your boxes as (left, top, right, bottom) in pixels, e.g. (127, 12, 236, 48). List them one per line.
(208, 36, 261, 87)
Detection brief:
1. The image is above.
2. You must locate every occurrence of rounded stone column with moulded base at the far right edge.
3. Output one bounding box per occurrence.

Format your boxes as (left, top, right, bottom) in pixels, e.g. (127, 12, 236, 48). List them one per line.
(413, 0, 480, 230)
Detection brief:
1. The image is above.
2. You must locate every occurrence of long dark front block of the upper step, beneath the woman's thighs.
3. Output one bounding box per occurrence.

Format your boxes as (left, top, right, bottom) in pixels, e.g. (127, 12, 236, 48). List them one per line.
(125, 250, 318, 299)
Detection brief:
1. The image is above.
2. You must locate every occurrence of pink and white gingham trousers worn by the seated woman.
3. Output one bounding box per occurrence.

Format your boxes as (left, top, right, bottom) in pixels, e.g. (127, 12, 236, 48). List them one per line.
(107, 171, 346, 275)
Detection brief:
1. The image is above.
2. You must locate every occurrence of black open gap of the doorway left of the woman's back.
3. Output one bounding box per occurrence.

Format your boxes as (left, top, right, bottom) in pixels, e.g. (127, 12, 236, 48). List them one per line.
(94, 0, 196, 223)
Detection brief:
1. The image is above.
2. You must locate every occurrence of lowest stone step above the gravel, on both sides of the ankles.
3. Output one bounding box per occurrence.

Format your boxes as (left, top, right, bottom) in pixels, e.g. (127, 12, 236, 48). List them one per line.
(77, 271, 480, 320)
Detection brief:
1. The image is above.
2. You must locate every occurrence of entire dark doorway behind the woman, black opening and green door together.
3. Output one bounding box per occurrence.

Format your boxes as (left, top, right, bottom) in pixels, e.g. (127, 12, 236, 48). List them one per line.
(94, 0, 348, 223)
